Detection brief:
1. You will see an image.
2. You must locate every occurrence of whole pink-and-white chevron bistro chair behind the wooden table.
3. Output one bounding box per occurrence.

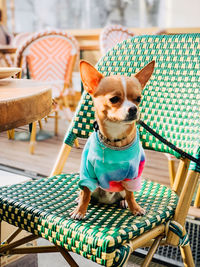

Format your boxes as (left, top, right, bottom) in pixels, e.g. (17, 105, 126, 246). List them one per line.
(15, 30, 79, 154)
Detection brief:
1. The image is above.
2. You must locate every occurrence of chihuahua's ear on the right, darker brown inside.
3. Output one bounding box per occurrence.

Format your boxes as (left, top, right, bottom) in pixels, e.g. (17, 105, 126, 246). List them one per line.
(135, 60, 155, 89)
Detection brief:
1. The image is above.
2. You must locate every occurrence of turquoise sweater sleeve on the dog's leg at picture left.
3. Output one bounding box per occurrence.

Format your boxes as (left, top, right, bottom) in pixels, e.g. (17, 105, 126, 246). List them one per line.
(79, 139, 98, 192)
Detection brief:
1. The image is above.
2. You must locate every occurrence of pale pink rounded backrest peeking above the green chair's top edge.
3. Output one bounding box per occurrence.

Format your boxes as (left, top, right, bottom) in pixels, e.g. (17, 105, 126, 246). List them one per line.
(100, 25, 134, 55)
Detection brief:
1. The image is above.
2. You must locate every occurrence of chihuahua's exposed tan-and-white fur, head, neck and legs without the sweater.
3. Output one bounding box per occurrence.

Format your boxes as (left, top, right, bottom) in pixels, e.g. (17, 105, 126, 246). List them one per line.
(71, 61, 155, 219)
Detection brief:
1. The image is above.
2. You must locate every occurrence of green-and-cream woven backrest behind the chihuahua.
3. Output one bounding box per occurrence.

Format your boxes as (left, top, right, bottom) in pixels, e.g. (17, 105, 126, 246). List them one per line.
(65, 34, 200, 172)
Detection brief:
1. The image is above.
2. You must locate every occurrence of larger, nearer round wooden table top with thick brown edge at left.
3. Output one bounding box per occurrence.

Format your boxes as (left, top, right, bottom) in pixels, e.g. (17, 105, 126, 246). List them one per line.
(0, 79, 52, 132)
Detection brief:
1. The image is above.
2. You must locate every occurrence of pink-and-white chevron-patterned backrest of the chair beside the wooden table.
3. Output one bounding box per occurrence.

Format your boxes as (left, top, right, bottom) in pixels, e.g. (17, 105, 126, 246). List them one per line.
(15, 30, 79, 96)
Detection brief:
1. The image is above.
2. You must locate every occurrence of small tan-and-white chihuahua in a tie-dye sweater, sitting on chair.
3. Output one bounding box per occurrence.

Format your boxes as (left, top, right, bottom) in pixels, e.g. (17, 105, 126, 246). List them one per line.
(71, 61, 155, 220)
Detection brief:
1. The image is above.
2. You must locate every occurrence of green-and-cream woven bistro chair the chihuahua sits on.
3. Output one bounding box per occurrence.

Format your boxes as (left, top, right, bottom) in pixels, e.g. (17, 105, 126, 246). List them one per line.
(0, 34, 200, 266)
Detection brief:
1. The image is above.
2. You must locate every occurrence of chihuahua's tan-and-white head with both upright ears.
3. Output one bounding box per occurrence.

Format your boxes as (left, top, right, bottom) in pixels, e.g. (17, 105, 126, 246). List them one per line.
(80, 61, 155, 124)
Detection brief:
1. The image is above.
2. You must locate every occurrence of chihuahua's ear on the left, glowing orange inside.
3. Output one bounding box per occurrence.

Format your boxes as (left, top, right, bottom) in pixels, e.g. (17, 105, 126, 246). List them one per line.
(80, 60, 103, 95)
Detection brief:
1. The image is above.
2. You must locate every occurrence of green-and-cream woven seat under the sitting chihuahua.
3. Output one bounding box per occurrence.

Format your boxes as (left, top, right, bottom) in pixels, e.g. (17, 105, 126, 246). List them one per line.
(0, 173, 178, 266)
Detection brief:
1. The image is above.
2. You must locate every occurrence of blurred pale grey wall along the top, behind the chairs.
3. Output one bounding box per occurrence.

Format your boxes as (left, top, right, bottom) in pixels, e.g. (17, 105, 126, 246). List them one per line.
(7, 0, 200, 32)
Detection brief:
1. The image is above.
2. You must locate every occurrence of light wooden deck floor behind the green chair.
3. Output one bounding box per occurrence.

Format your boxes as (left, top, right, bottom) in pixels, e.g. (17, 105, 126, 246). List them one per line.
(0, 116, 173, 185)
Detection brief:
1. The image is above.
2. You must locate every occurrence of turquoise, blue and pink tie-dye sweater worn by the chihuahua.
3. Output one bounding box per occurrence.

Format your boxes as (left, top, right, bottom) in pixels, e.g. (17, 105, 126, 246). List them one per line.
(79, 131, 145, 192)
